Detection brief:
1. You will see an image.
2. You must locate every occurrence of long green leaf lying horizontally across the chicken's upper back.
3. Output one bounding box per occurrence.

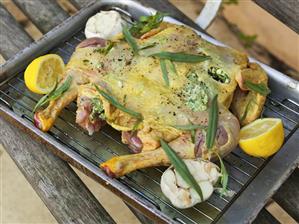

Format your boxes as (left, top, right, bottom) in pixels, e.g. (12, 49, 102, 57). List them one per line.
(150, 51, 211, 63)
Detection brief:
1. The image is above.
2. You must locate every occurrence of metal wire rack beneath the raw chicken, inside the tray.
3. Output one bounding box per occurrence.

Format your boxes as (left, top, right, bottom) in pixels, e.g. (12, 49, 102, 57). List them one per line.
(0, 1, 299, 223)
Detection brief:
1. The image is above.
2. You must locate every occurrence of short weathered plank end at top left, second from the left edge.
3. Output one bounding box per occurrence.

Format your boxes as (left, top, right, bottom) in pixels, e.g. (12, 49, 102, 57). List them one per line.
(13, 0, 69, 33)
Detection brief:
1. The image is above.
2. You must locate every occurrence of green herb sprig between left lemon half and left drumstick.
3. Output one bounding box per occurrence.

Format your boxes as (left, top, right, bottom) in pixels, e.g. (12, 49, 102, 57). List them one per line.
(33, 76, 73, 112)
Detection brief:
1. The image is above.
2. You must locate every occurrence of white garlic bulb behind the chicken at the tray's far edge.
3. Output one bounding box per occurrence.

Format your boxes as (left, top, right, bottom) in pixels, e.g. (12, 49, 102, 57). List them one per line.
(85, 10, 125, 40)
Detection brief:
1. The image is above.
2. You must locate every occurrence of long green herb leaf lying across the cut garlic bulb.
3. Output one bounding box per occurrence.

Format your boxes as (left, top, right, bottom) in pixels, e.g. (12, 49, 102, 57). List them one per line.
(160, 139, 204, 201)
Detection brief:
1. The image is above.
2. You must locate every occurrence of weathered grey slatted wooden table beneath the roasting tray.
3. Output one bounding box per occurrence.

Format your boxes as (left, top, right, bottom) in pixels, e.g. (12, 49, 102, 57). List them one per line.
(0, 0, 299, 223)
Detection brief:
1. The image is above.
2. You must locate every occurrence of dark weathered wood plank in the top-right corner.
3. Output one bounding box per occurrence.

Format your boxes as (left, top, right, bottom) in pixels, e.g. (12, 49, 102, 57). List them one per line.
(254, 0, 299, 33)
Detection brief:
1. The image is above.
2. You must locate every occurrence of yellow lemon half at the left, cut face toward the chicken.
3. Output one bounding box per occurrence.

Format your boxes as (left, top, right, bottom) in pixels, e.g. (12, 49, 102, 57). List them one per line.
(24, 54, 65, 94)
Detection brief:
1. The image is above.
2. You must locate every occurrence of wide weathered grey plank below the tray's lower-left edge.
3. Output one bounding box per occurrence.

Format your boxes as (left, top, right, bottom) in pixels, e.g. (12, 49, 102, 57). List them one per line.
(0, 118, 114, 224)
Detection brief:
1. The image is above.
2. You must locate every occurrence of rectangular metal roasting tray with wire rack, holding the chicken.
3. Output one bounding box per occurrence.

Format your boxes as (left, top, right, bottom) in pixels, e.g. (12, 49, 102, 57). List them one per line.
(0, 0, 299, 223)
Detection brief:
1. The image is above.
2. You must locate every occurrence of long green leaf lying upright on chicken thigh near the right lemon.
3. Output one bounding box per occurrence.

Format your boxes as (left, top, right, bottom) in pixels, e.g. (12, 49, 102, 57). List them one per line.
(206, 94, 218, 149)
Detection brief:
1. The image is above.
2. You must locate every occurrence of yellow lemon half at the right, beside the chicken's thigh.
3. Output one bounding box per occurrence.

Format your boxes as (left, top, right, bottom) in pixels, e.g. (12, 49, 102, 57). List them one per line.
(239, 118, 284, 158)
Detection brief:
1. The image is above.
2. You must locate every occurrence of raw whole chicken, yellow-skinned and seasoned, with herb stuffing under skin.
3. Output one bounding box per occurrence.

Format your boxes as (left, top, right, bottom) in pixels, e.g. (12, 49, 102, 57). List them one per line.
(34, 22, 268, 177)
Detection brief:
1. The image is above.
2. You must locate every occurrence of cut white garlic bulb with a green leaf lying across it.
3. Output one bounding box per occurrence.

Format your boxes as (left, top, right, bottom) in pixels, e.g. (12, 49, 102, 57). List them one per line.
(161, 159, 221, 208)
